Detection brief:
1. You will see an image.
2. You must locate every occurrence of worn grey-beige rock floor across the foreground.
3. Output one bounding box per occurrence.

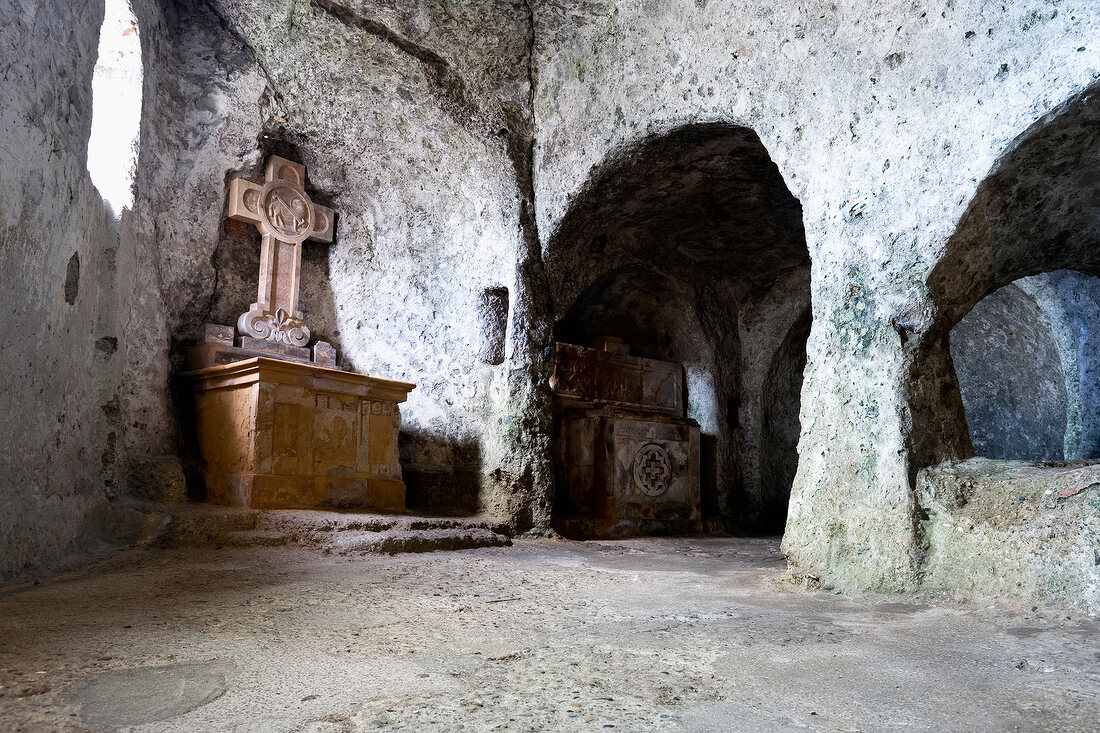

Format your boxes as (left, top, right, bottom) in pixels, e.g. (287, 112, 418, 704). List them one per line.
(0, 530, 1100, 733)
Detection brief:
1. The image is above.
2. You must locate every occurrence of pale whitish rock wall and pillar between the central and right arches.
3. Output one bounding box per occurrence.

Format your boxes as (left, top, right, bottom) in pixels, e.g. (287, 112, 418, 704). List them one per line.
(536, 1, 1100, 589)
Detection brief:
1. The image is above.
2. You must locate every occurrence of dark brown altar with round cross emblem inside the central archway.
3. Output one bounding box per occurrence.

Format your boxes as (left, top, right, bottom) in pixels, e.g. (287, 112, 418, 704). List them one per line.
(550, 339, 702, 538)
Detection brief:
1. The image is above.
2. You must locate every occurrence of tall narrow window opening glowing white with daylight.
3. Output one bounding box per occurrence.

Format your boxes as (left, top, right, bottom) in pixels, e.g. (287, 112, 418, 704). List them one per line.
(88, 0, 142, 215)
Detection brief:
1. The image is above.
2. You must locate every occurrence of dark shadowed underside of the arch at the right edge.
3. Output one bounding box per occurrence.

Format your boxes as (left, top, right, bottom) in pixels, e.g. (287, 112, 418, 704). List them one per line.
(909, 84, 1100, 468)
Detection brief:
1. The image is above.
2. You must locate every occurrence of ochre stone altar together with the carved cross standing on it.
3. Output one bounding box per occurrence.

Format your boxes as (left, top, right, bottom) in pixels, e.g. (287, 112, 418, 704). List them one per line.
(184, 156, 415, 511)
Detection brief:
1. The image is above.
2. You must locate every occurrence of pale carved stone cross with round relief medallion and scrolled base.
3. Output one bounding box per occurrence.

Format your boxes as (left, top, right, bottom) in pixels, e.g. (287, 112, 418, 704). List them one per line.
(229, 155, 332, 347)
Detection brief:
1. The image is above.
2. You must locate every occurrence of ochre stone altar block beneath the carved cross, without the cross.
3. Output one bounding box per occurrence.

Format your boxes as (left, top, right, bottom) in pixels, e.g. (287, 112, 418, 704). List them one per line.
(191, 357, 414, 510)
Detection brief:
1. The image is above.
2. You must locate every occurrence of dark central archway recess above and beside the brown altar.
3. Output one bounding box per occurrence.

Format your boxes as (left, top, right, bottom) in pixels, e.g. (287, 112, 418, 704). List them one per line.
(546, 123, 810, 532)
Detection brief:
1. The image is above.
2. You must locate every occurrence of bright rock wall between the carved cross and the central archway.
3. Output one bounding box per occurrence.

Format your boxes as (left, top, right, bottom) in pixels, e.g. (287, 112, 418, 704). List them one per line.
(191, 0, 539, 513)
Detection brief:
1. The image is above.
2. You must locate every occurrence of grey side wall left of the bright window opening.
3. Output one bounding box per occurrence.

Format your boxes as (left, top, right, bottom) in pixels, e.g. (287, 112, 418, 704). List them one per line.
(0, 1, 118, 578)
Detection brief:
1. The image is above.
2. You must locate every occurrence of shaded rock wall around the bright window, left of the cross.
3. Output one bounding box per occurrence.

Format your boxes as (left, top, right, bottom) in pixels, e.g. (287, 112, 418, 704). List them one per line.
(0, 0, 263, 575)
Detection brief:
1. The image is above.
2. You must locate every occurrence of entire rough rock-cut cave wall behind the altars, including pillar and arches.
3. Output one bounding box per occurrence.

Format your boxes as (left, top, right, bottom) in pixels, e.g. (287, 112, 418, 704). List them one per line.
(0, 0, 1100, 603)
